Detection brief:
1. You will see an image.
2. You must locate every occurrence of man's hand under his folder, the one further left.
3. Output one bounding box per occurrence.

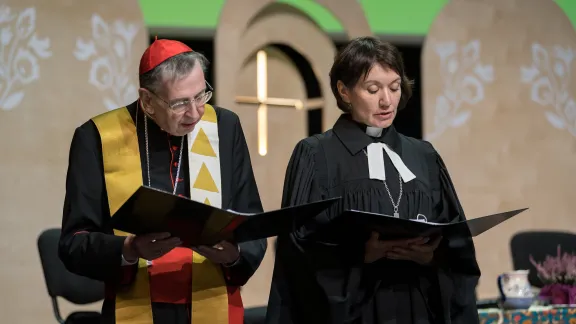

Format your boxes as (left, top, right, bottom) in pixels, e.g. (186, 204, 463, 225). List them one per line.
(122, 233, 182, 262)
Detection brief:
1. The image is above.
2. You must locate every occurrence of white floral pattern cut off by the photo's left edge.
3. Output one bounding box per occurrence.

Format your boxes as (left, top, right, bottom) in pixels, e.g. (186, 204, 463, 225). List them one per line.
(0, 5, 52, 110)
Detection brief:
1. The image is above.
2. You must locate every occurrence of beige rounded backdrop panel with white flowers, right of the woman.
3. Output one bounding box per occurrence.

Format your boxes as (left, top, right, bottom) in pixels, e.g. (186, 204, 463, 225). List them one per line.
(422, 0, 576, 297)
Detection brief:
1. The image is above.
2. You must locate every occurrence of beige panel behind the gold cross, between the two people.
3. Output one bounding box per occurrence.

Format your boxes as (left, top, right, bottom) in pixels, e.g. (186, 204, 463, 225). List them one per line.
(235, 45, 307, 306)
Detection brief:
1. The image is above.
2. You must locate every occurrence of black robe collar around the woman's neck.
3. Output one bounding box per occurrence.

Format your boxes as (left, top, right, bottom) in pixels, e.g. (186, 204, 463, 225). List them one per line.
(333, 114, 400, 155)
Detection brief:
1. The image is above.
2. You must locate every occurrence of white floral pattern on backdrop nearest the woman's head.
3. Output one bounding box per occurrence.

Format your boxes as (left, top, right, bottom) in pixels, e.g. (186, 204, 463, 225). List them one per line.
(426, 40, 494, 140)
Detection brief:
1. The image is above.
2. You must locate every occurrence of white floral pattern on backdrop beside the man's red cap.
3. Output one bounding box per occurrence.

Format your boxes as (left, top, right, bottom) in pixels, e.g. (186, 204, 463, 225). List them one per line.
(74, 14, 139, 110)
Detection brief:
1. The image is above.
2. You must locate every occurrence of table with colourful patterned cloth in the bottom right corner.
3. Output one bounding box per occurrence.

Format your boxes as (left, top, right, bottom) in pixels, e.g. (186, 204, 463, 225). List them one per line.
(478, 305, 576, 324)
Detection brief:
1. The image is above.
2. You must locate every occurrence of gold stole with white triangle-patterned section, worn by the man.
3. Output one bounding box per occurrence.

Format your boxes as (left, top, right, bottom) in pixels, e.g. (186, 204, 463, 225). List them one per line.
(92, 104, 228, 324)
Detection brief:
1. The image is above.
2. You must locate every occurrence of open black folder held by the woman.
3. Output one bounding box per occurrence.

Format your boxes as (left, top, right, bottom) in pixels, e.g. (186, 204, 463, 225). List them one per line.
(337, 208, 528, 239)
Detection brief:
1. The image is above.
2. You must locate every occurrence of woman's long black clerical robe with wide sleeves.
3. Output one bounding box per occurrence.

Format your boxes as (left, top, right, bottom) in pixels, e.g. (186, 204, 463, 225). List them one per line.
(267, 115, 480, 324)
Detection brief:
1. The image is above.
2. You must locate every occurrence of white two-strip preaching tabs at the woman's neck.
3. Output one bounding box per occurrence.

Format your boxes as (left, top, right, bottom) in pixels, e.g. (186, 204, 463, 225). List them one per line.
(366, 143, 416, 182)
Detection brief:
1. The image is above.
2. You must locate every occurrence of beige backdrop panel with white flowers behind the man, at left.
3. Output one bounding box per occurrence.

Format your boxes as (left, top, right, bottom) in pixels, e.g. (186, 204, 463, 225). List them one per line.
(0, 0, 148, 323)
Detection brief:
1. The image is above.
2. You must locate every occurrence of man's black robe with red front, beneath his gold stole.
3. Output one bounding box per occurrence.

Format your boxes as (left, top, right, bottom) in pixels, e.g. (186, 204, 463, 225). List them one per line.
(59, 103, 266, 324)
